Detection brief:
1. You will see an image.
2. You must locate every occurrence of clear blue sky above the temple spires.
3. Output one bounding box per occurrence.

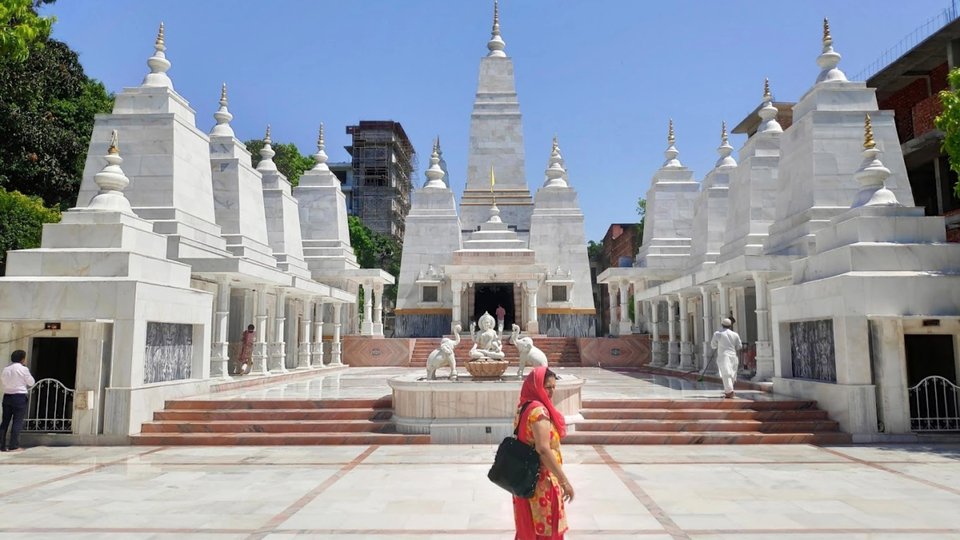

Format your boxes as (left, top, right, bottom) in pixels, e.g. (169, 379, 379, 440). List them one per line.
(43, 0, 950, 240)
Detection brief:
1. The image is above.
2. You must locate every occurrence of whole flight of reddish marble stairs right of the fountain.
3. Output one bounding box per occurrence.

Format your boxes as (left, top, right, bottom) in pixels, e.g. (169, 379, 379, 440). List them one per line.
(564, 399, 852, 445)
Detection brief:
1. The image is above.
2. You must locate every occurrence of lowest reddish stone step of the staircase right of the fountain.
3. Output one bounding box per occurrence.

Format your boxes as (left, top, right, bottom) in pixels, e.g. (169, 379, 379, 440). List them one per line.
(563, 431, 853, 445)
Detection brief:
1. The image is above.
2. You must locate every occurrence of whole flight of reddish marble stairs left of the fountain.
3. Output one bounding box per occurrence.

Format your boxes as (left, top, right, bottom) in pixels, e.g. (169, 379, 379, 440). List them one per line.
(132, 397, 430, 446)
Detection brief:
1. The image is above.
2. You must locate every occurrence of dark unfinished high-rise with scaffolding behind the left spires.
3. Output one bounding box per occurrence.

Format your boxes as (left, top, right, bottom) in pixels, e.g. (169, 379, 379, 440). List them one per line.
(346, 120, 416, 241)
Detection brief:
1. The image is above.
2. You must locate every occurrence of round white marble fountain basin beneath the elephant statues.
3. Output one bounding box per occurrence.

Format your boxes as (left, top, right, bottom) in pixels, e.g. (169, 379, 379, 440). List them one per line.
(387, 370, 584, 444)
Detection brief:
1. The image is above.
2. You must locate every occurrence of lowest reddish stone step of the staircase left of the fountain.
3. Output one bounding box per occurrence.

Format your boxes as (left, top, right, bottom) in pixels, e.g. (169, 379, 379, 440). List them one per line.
(131, 432, 430, 446)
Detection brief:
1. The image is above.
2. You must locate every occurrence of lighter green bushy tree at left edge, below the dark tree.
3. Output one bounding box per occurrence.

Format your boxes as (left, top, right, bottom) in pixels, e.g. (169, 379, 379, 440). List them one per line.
(0, 188, 60, 275)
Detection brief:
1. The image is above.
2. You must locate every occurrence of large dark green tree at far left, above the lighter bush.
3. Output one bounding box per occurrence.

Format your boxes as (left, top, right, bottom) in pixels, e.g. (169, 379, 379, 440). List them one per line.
(0, 40, 113, 209)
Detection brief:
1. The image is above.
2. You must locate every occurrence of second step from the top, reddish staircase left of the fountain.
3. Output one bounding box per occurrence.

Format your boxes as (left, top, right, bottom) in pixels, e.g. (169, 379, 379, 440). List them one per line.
(153, 408, 393, 422)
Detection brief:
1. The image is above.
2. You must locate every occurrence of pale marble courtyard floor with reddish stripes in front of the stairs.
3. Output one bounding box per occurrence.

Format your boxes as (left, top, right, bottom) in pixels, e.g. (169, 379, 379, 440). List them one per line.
(0, 445, 960, 540)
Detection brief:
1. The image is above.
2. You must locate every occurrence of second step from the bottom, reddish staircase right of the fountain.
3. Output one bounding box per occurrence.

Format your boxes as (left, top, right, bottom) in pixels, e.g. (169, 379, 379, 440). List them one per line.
(577, 420, 839, 433)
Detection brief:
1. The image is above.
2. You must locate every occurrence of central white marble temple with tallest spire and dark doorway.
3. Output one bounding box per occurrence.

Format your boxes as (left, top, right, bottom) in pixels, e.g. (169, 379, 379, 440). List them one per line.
(395, 4, 596, 337)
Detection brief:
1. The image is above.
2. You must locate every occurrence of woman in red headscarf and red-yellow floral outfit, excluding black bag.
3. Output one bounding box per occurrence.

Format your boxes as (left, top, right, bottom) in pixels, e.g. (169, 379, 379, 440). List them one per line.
(513, 366, 573, 540)
